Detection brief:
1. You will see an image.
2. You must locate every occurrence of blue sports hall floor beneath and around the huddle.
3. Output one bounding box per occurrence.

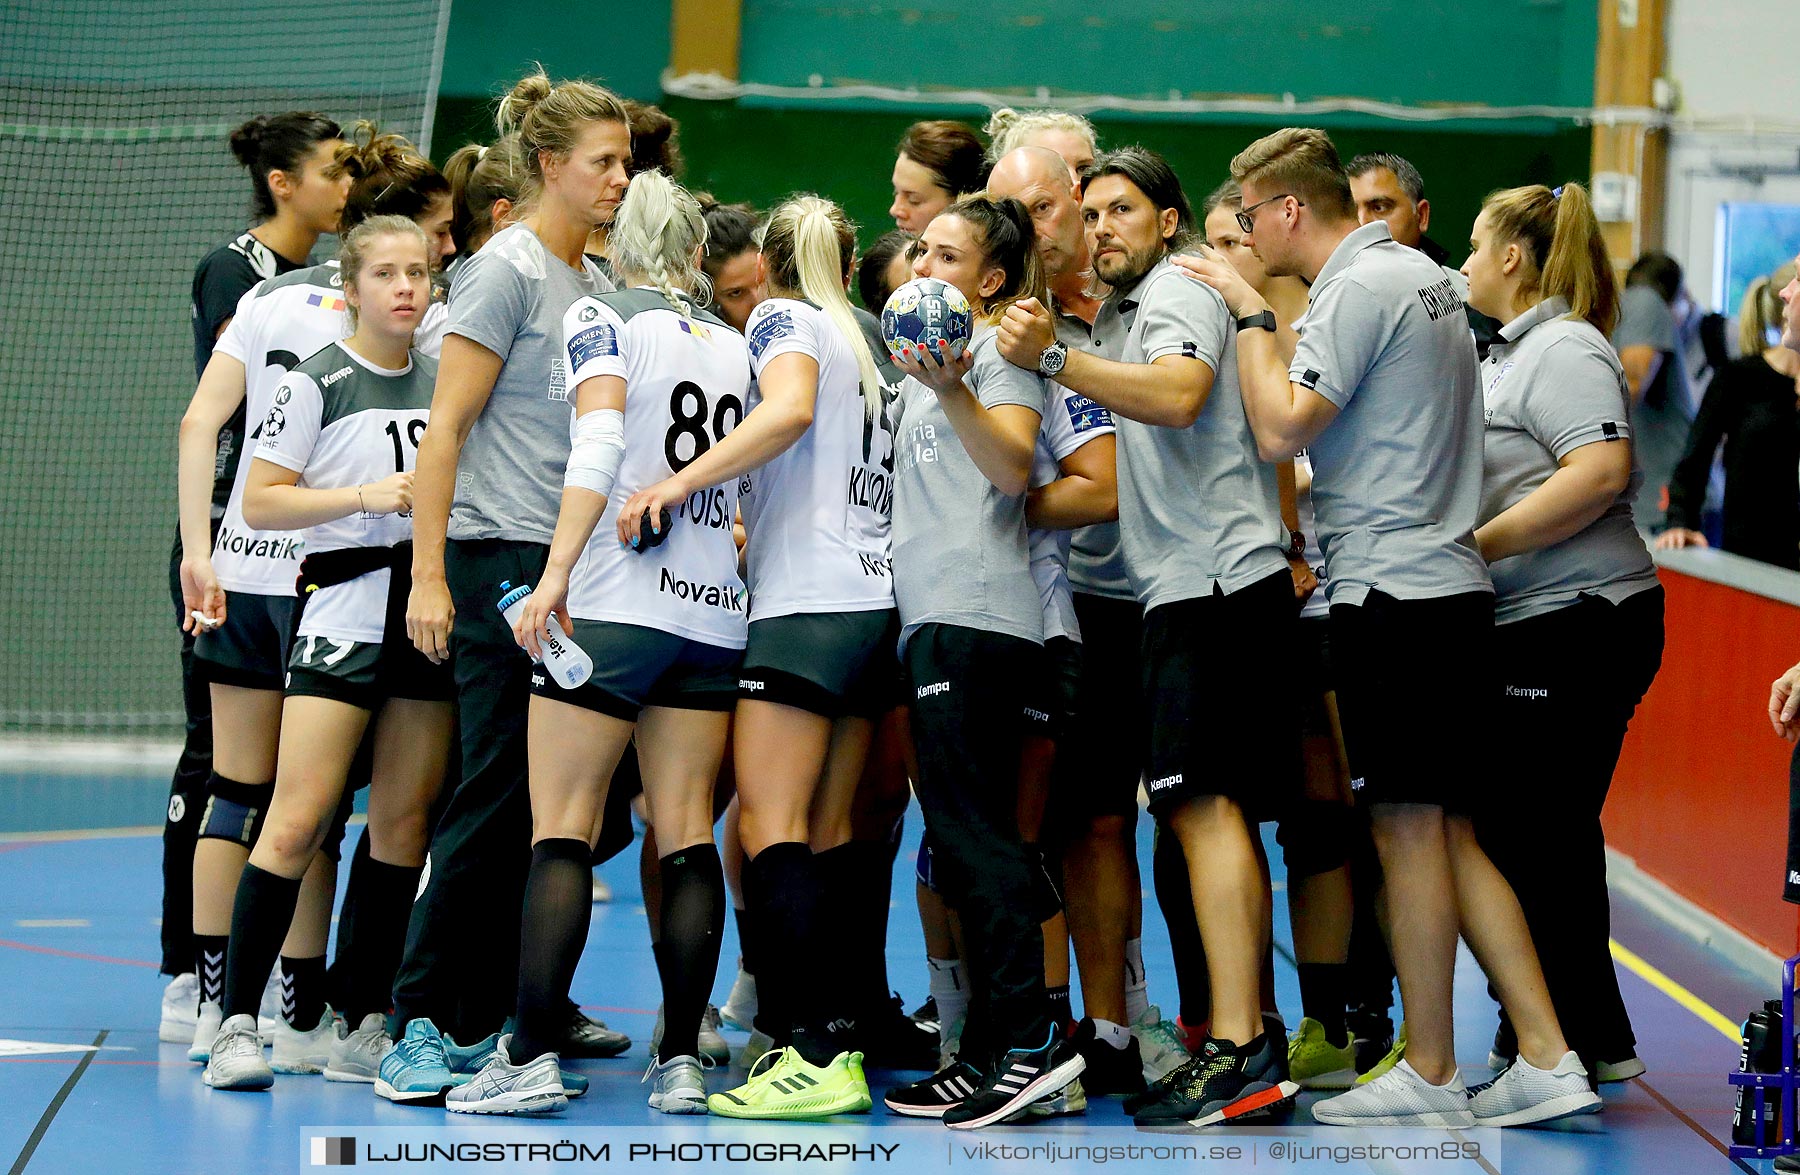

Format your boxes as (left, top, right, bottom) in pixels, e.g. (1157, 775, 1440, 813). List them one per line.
(0, 774, 1775, 1175)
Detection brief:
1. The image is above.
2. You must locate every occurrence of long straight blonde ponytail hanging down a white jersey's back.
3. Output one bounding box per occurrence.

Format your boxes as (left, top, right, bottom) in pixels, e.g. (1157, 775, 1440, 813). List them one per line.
(763, 196, 882, 421)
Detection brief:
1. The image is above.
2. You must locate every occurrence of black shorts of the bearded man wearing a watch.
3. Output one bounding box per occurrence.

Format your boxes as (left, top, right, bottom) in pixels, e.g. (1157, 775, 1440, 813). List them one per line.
(1143, 567, 1301, 821)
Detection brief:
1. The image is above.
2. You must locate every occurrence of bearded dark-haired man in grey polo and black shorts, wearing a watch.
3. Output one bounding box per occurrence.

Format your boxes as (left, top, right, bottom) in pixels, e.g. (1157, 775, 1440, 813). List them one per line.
(999, 148, 1300, 1126)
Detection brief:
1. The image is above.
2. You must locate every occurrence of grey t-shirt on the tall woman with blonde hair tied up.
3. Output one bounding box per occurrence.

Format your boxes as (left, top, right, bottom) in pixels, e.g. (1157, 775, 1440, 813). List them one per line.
(445, 225, 612, 543)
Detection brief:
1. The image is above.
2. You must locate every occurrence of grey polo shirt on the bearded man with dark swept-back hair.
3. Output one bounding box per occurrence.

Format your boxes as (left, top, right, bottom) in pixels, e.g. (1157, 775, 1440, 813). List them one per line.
(1094, 257, 1287, 610)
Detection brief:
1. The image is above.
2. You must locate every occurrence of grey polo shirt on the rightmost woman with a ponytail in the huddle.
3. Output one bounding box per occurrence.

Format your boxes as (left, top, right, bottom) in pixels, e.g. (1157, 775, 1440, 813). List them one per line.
(1481, 299, 1656, 624)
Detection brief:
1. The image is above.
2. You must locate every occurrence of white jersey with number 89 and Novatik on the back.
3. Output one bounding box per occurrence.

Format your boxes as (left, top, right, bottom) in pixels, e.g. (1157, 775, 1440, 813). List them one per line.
(563, 288, 751, 648)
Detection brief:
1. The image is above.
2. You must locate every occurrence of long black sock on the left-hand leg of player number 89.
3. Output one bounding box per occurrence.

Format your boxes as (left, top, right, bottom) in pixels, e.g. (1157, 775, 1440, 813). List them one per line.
(508, 837, 594, 1065)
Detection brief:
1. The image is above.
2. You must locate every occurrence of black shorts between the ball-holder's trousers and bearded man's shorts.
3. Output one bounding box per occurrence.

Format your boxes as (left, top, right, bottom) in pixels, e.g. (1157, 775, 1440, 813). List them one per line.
(1051, 592, 1150, 824)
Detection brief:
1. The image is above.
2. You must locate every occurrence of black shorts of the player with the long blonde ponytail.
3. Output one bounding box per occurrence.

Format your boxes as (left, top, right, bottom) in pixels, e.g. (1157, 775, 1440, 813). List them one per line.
(738, 608, 900, 718)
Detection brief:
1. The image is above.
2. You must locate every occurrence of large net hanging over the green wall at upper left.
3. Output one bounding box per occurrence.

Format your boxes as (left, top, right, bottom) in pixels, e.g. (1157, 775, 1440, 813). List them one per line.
(0, 0, 450, 732)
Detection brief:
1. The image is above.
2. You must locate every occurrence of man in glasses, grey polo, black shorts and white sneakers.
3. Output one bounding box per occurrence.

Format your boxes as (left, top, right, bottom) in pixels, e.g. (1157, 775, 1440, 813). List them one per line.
(1183, 128, 1600, 1128)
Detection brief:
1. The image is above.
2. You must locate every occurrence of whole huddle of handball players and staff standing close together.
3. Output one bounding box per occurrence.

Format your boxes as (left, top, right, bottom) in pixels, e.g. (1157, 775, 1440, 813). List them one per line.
(162, 74, 1663, 1130)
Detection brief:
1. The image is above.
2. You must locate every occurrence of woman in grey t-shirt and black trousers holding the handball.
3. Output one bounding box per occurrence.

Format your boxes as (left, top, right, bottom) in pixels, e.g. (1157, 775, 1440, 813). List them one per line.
(884, 196, 1082, 1130)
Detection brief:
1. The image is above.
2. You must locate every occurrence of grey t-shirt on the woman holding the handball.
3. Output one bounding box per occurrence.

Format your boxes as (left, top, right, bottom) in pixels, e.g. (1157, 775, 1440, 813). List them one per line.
(893, 327, 1046, 650)
